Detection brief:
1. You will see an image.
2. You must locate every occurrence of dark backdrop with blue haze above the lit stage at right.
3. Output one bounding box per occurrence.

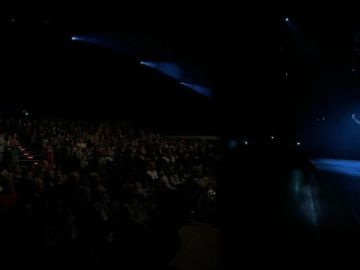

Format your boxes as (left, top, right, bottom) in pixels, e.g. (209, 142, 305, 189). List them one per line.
(217, 1, 360, 154)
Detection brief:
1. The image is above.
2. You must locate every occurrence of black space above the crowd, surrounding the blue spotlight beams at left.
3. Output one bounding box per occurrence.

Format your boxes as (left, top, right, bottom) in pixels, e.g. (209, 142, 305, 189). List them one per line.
(0, 3, 218, 135)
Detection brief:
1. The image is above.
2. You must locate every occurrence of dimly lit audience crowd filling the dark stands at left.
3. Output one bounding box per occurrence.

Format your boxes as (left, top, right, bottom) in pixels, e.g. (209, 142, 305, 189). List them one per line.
(0, 118, 220, 269)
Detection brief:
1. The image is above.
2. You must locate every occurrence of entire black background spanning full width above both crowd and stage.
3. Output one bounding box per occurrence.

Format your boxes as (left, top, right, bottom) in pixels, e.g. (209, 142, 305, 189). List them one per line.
(0, 1, 360, 143)
